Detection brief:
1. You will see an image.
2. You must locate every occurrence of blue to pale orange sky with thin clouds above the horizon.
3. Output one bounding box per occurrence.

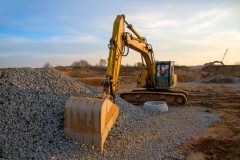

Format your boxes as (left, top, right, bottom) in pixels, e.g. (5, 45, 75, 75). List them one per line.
(0, 0, 240, 68)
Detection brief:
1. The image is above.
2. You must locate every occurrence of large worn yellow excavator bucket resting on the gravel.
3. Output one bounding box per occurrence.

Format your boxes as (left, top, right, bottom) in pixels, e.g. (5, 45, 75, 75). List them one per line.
(64, 97, 119, 151)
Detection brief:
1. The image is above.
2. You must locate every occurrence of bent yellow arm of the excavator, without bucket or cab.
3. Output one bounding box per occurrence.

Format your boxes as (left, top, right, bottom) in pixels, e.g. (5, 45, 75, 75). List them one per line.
(103, 15, 155, 99)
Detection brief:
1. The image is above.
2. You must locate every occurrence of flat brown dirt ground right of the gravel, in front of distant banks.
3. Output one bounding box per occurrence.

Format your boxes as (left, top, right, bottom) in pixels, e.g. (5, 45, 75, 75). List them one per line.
(178, 84, 240, 160)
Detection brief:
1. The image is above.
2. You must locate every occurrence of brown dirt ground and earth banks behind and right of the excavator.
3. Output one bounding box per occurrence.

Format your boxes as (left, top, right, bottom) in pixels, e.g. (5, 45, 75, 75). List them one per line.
(57, 66, 240, 160)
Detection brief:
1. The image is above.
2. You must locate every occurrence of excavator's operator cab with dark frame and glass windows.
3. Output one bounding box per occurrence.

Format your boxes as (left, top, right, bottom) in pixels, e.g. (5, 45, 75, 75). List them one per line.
(155, 61, 177, 89)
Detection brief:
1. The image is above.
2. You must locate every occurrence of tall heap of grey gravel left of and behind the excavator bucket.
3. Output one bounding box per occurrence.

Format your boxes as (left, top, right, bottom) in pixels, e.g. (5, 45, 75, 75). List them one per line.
(0, 68, 145, 159)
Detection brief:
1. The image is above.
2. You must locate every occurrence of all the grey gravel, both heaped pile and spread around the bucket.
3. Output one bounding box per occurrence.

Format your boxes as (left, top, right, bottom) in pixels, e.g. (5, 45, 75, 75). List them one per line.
(0, 68, 220, 159)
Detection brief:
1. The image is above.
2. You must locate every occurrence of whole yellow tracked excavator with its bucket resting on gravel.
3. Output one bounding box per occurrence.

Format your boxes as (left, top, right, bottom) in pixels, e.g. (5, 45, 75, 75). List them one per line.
(64, 15, 187, 151)
